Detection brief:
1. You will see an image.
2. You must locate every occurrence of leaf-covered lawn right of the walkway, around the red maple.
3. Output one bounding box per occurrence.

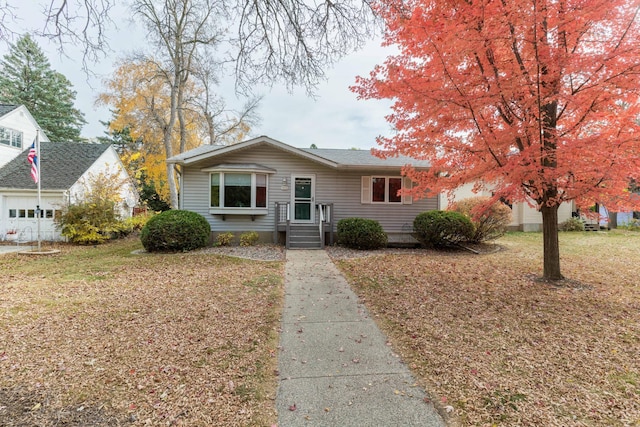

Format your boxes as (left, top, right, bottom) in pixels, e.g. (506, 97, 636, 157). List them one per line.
(339, 232, 640, 426)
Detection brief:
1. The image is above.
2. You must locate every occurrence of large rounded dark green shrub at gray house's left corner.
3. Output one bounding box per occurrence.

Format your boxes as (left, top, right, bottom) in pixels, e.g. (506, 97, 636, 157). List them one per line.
(140, 210, 211, 252)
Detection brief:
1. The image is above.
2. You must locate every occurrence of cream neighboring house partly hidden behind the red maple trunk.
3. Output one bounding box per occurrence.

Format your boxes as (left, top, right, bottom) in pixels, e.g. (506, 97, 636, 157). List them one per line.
(440, 184, 574, 231)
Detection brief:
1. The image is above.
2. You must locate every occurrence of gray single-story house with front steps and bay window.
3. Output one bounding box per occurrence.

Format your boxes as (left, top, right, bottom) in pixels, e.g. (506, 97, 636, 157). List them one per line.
(167, 136, 440, 248)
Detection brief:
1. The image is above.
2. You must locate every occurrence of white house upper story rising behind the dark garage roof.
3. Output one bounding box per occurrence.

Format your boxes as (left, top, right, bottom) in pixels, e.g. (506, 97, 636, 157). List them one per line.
(0, 104, 49, 167)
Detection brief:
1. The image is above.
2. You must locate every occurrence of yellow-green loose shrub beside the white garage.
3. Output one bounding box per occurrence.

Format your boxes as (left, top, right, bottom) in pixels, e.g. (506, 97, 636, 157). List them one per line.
(55, 200, 121, 245)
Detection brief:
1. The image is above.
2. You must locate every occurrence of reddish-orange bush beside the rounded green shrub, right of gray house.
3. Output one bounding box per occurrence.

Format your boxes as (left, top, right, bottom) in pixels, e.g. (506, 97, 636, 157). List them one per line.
(449, 197, 511, 243)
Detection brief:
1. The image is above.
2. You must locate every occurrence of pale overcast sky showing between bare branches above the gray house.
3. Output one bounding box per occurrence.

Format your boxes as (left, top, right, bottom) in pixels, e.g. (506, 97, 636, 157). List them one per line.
(0, 1, 390, 149)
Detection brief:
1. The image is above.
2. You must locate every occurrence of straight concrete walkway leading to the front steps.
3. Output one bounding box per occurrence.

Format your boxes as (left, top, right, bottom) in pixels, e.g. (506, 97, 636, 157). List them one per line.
(276, 250, 445, 427)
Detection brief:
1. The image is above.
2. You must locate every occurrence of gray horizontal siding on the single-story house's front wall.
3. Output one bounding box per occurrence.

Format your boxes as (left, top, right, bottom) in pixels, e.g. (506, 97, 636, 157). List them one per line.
(182, 146, 438, 233)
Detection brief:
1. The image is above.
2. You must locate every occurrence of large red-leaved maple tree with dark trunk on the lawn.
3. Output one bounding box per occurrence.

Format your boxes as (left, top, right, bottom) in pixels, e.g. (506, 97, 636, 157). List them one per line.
(352, 0, 640, 280)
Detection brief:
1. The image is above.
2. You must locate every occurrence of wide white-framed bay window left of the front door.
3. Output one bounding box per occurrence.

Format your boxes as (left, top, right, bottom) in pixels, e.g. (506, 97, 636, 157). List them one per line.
(209, 171, 268, 214)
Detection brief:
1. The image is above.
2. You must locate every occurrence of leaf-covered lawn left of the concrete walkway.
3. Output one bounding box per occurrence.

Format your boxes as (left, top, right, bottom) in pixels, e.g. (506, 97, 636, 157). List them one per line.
(0, 240, 283, 426)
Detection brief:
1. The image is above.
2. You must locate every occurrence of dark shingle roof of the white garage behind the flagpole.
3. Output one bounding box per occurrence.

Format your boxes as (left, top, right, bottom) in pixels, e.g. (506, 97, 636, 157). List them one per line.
(0, 141, 109, 190)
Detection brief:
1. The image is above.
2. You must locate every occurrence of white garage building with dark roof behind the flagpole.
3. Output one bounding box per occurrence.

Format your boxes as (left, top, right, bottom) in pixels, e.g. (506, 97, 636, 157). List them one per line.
(0, 141, 138, 241)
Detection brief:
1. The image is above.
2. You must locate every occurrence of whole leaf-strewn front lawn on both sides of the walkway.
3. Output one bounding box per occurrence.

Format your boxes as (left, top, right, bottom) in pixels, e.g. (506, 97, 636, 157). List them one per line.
(0, 232, 640, 426)
